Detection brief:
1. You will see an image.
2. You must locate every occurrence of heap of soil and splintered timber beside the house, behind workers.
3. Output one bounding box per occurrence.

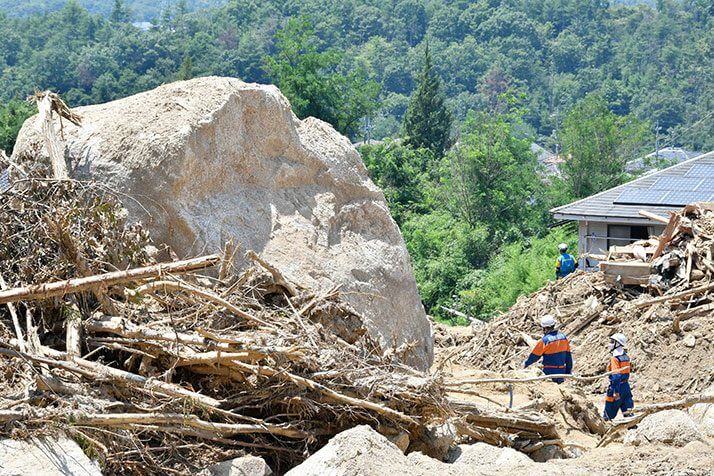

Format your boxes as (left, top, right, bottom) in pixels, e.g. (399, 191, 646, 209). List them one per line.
(453, 204, 714, 400)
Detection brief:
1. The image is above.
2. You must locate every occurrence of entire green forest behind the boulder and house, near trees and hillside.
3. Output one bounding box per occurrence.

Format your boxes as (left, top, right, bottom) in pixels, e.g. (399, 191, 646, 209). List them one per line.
(0, 0, 714, 324)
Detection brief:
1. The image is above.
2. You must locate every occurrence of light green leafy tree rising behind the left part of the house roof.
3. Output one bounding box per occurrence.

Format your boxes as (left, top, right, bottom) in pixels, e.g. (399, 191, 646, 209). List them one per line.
(560, 94, 651, 198)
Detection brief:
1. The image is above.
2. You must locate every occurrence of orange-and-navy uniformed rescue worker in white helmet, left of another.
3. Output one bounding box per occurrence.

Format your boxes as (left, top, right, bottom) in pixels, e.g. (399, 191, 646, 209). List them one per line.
(525, 314, 573, 384)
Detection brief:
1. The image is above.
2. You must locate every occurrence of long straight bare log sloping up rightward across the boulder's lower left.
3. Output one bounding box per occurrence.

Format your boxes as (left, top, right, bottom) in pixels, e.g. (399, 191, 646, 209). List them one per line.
(0, 255, 221, 304)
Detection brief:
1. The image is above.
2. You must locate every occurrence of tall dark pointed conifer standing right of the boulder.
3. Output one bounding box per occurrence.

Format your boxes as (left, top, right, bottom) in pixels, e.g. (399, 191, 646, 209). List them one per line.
(404, 42, 452, 157)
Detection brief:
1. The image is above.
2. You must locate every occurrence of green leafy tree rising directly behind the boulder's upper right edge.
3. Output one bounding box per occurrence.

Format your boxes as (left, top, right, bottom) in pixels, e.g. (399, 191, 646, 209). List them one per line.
(264, 17, 379, 134)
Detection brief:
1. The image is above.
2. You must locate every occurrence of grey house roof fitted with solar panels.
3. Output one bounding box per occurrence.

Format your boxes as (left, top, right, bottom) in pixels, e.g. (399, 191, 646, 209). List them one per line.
(550, 151, 714, 223)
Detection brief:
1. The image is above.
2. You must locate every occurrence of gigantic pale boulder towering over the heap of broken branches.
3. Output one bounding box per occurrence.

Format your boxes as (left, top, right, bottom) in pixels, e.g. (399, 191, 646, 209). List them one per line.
(14, 77, 433, 369)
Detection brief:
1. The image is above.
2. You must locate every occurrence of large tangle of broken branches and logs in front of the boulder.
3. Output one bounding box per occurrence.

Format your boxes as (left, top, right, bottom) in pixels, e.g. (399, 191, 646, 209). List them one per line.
(0, 179, 572, 474)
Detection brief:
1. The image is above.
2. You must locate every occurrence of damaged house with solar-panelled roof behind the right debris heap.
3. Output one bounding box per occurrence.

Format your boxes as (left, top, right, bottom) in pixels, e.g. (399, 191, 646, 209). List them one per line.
(551, 151, 714, 269)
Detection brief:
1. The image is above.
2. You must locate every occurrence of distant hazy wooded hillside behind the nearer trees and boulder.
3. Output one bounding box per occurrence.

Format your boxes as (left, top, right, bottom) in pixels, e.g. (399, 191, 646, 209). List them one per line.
(0, 0, 714, 150)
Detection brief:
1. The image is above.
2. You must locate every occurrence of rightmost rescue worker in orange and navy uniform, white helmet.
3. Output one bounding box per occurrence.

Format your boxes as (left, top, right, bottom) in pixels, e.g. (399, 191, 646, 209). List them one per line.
(602, 333, 635, 420)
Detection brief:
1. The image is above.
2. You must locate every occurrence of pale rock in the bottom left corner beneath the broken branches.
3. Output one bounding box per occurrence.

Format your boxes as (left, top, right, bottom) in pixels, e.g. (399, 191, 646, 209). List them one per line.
(0, 436, 102, 476)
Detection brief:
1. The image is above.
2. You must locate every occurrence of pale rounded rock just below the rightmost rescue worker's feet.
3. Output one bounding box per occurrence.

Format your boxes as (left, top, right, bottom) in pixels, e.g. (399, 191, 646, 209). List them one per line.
(624, 410, 702, 446)
